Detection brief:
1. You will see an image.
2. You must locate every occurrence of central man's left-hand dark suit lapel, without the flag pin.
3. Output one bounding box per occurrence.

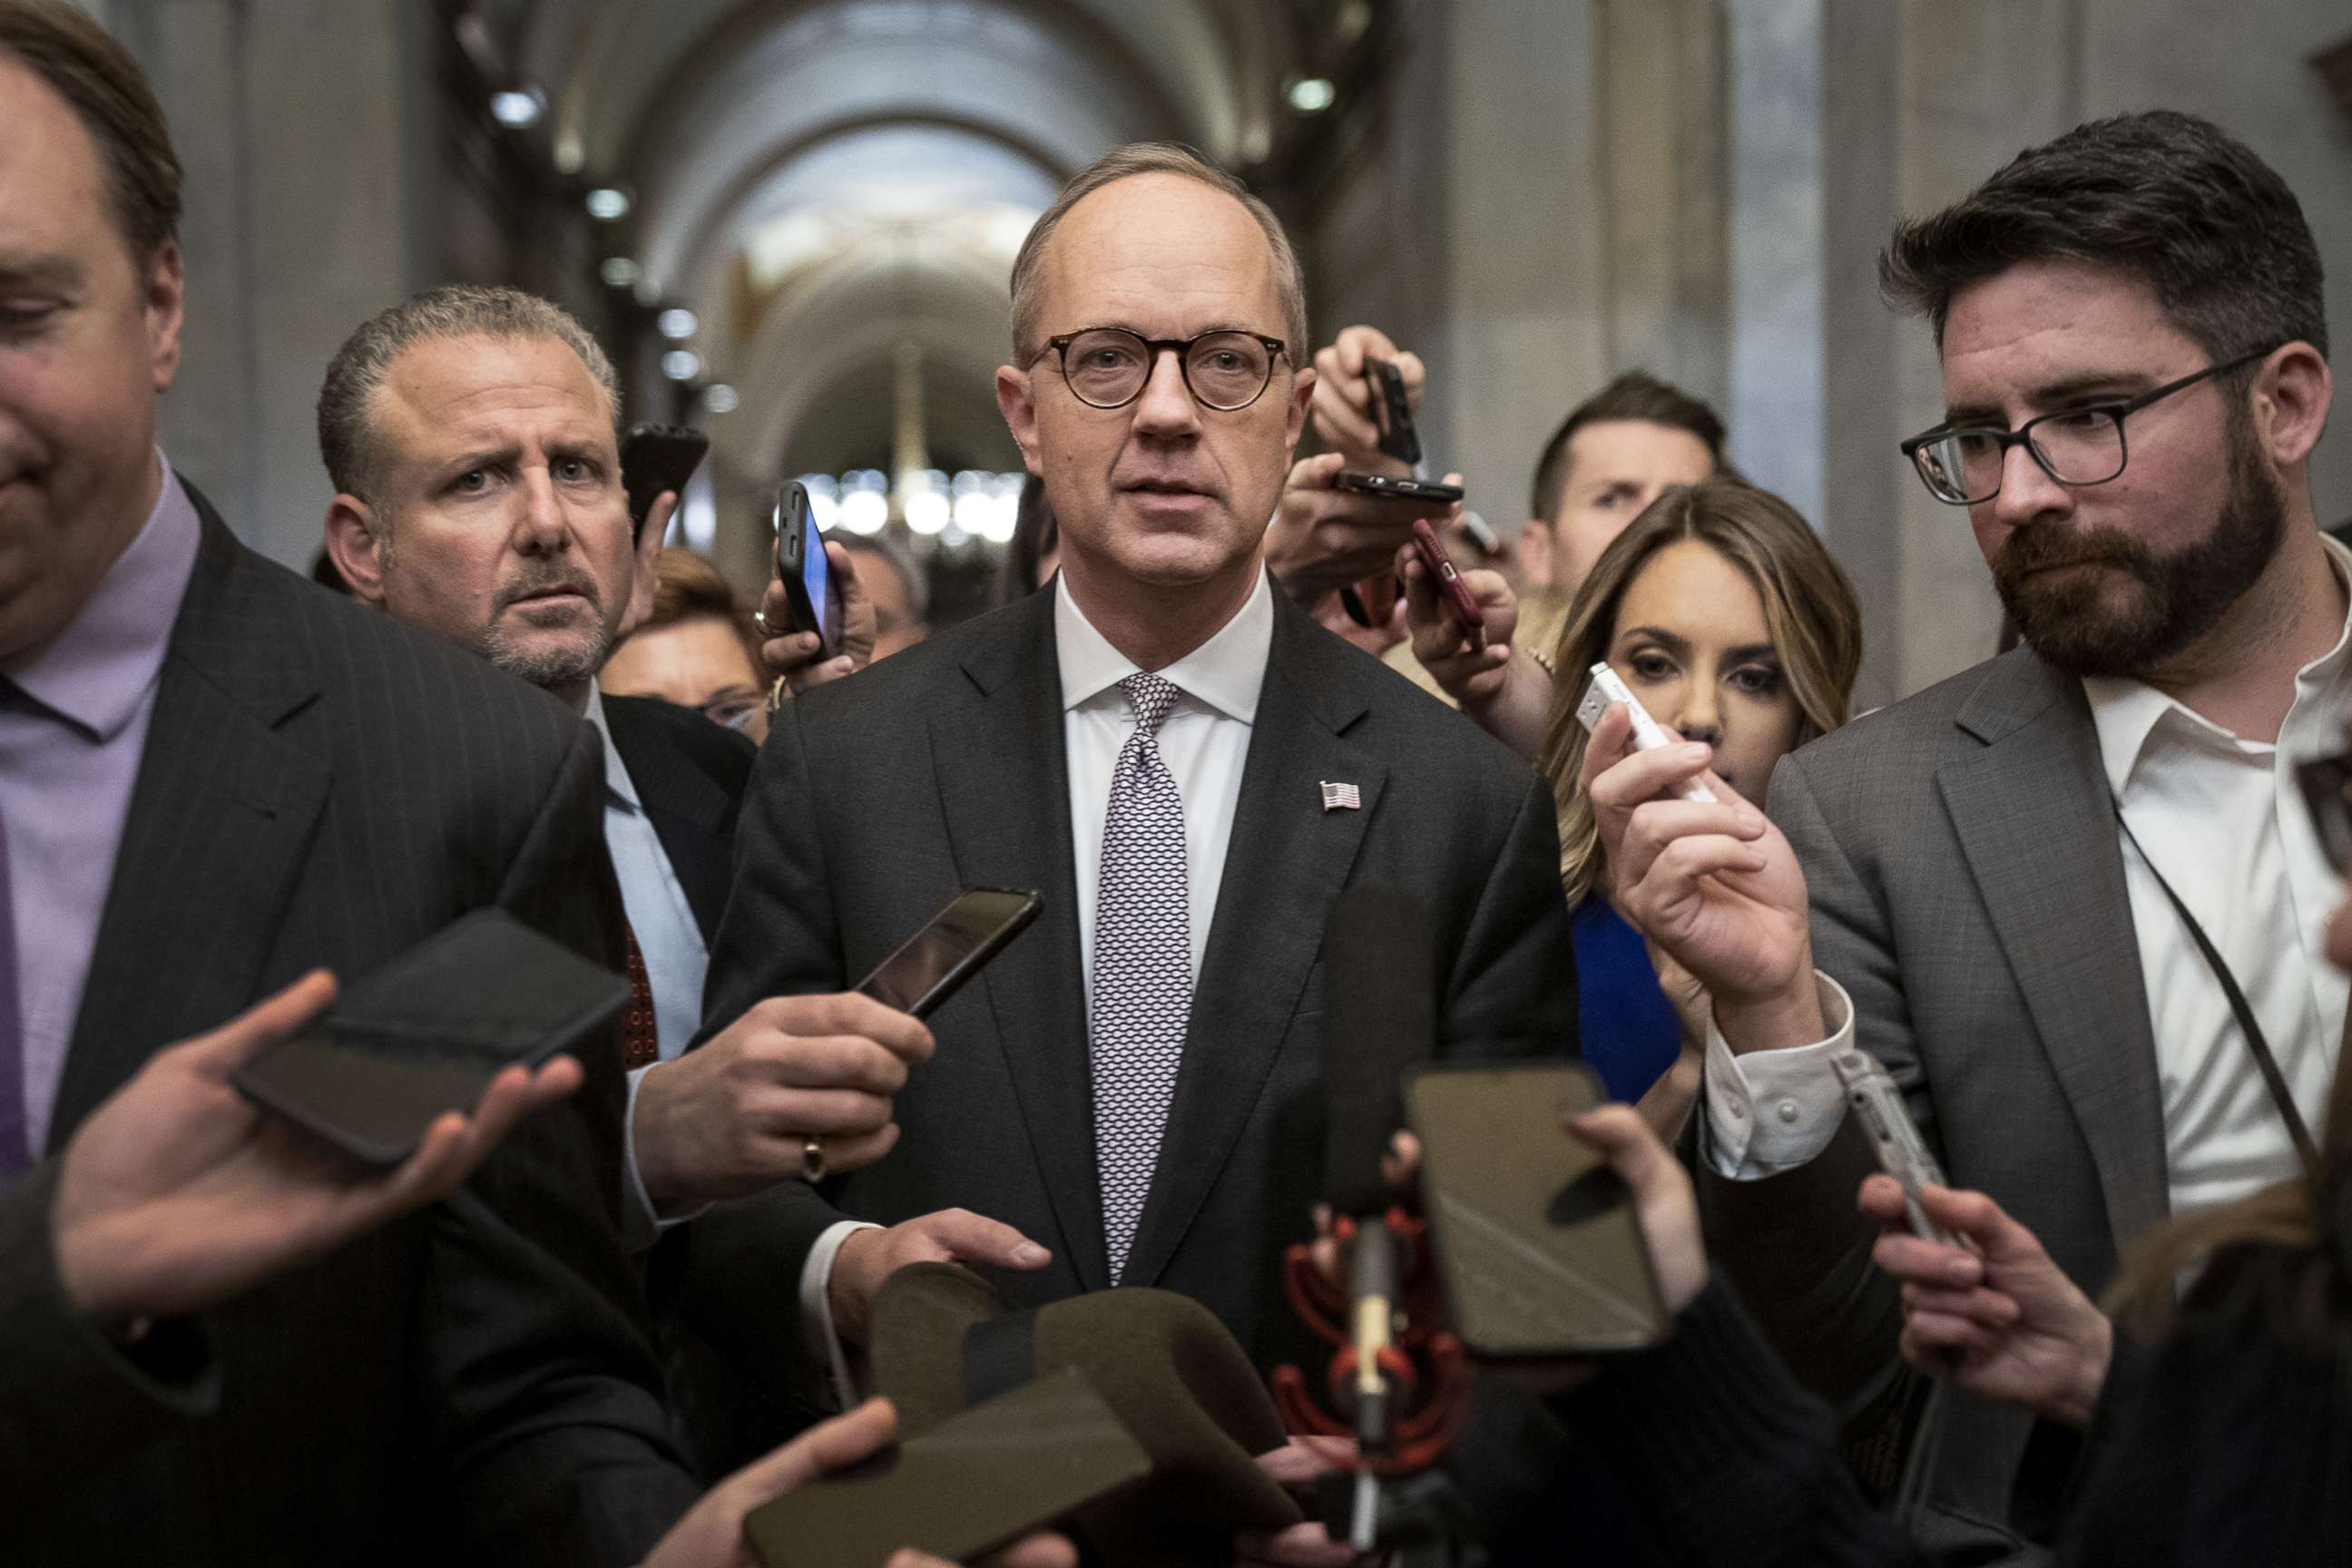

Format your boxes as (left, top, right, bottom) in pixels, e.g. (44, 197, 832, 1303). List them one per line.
(931, 593, 1110, 1290)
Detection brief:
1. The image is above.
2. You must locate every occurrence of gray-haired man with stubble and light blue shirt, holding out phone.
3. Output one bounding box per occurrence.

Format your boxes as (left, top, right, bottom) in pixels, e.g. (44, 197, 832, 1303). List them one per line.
(318, 284, 931, 1288)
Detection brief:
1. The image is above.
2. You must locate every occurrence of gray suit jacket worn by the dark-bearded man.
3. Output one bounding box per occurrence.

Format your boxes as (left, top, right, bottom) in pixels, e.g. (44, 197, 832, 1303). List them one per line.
(1700, 646, 2166, 1561)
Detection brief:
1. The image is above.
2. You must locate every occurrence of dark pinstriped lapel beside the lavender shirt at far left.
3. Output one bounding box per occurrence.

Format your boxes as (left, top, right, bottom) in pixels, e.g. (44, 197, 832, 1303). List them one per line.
(49, 510, 329, 1147)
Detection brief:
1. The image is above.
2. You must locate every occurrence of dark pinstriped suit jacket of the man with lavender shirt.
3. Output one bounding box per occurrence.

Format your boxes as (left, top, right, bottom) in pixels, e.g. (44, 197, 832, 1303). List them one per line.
(0, 501, 696, 1568)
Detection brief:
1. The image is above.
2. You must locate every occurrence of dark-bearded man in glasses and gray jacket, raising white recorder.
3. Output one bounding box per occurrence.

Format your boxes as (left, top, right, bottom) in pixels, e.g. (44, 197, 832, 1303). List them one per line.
(1588, 113, 2352, 1547)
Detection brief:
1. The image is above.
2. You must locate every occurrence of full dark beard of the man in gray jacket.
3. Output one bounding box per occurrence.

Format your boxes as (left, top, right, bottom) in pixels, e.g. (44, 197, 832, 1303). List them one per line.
(1992, 411, 2286, 677)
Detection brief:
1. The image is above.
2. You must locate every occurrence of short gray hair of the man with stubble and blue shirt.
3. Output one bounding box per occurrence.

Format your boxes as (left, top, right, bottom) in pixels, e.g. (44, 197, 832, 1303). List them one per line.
(318, 284, 621, 501)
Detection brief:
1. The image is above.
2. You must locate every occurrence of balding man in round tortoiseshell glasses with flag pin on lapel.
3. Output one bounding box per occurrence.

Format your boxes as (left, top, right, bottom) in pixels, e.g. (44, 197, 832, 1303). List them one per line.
(672, 148, 1576, 1523)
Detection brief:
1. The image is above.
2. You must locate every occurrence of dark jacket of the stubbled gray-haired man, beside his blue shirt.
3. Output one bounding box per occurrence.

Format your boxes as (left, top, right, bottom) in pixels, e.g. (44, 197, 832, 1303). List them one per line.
(603, 691, 760, 943)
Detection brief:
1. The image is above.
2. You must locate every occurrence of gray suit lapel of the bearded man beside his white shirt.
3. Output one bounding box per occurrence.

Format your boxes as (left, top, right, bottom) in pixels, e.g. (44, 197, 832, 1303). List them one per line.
(1936, 652, 2169, 1241)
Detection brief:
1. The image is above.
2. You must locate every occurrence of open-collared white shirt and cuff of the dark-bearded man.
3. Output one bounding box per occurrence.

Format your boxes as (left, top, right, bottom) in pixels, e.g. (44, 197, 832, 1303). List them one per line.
(1705, 541, 2352, 1213)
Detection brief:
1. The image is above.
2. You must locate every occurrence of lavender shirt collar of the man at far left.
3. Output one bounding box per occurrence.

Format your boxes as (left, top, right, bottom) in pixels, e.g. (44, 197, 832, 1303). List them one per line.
(7, 451, 205, 743)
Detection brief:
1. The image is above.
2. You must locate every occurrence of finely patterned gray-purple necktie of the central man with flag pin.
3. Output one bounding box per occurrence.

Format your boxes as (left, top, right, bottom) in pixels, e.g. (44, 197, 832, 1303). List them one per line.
(1089, 675, 1192, 1284)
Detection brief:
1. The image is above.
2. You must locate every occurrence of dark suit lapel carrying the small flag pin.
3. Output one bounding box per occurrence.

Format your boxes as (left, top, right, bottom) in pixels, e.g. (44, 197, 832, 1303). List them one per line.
(1124, 590, 1387, 1286)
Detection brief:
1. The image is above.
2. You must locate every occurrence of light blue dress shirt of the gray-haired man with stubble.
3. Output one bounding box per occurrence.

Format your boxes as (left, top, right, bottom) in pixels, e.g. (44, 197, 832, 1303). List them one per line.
(583, 681, 710, 1249)
